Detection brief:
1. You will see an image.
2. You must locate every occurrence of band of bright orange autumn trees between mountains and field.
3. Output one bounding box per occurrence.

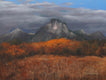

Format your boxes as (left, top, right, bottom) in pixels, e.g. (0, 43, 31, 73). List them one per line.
(0, 38, 106, 59)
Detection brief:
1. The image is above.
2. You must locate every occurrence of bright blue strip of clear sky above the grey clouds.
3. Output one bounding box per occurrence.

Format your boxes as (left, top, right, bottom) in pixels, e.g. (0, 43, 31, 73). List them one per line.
(5, 0, 106, 10)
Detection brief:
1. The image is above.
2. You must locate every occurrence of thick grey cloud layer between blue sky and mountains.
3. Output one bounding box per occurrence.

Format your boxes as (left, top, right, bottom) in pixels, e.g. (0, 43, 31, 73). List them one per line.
(0, 0, 106, 34)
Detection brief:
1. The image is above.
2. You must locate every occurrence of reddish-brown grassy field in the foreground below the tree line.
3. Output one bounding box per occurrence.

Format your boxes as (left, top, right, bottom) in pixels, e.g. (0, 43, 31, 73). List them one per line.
(0, 55, 106, 80)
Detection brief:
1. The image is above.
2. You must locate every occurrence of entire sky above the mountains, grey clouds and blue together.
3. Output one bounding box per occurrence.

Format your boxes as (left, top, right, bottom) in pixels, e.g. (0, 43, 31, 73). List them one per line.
(0, 0, 106, 35)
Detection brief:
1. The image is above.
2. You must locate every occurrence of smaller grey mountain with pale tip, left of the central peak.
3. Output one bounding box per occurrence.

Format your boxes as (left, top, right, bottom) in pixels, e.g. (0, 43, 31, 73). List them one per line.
(0, 28, 33, 42)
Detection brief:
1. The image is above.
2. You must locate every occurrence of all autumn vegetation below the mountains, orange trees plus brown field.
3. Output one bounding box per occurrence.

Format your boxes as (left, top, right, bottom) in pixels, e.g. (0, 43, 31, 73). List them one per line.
(0, 38, 106, 80)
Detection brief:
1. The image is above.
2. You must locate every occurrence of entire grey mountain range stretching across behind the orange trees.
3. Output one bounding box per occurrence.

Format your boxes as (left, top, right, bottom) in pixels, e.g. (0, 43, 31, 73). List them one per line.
(0, 19, 106, 42)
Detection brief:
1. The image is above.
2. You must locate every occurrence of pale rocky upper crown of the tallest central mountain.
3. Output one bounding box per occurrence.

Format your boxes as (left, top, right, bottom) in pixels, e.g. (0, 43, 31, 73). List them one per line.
(45, 19, 69, 35)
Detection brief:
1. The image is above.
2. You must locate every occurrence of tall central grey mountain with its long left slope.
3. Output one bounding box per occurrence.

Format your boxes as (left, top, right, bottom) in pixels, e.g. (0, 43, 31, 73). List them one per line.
(32, 19, 70, 41)
